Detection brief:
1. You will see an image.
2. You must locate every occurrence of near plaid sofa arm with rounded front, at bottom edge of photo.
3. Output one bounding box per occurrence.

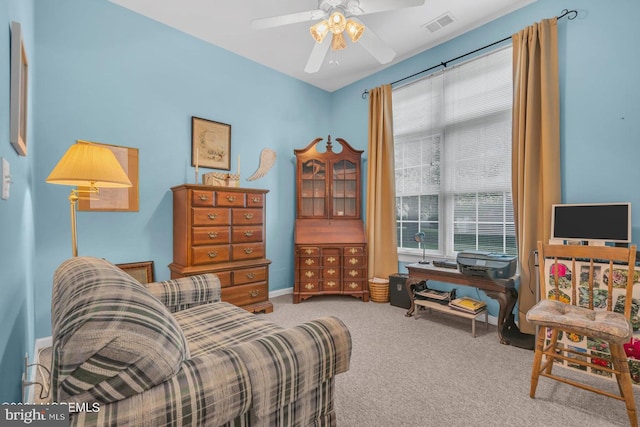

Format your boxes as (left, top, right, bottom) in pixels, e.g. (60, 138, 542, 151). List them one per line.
(71, 350, 251, 427)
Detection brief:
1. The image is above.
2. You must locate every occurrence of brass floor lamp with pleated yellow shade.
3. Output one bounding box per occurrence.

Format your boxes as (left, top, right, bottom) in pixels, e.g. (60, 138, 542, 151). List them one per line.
(46, 141, 131, 257)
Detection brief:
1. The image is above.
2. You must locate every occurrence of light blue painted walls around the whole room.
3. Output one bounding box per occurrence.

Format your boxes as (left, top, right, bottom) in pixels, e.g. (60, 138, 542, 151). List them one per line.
(0, 0, 640, 401)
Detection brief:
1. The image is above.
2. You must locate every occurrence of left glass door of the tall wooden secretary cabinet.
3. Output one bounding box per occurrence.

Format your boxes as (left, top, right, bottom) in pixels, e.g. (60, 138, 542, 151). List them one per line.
(300, 159, 327, 217)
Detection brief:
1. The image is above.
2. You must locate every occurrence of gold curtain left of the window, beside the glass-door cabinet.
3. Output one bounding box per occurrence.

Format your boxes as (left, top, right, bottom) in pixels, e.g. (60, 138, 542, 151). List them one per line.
(366, 84, 398, 278)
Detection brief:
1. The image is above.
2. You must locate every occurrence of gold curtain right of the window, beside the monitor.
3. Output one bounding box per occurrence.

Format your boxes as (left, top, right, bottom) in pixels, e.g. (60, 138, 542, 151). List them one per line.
(512, 18, 560, 334)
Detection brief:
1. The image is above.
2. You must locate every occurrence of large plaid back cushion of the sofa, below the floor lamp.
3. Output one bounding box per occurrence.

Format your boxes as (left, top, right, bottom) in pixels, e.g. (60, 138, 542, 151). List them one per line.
(51, 257, 189, 403)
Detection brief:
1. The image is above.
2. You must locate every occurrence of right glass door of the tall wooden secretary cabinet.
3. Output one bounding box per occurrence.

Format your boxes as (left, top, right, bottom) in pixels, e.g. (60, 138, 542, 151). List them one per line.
(331, 160, 358, 218)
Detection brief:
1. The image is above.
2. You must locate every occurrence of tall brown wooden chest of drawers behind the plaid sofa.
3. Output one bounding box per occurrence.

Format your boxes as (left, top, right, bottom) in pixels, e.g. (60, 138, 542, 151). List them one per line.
(169, 184, 273, 313)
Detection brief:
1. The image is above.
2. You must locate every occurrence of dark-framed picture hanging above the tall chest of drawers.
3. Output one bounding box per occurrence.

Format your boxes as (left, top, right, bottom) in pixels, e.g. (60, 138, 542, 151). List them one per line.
(191, 117, 231, 170)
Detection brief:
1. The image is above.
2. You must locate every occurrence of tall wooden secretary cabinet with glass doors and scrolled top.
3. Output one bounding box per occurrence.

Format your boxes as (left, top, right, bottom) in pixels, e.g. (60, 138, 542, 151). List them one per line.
(293, 136, 369, 304)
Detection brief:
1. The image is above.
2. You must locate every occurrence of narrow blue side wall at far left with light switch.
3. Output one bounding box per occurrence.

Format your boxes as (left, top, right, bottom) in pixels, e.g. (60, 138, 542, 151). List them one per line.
(0, 0, 38, 402)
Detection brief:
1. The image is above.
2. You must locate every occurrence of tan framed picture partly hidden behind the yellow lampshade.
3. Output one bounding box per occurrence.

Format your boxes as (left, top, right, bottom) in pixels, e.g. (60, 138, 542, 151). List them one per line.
(78, 142, 139, 212)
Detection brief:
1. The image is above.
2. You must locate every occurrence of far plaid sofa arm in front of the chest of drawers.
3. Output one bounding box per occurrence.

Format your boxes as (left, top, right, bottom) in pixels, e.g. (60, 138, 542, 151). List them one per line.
(144, 273, 220, 313)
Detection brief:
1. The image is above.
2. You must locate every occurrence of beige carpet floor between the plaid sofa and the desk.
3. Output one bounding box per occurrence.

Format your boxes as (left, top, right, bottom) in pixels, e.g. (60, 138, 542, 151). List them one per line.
(263, 295, 640, 427)
